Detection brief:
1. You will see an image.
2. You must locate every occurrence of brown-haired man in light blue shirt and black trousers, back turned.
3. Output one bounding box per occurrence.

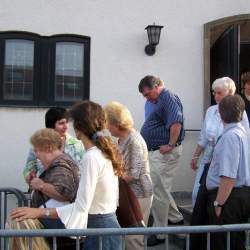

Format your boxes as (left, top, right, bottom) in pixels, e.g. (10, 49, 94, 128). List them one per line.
(206, 95, 250, 250)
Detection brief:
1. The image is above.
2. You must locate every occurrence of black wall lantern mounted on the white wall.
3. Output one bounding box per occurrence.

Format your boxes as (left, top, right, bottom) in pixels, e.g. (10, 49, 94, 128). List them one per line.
(145, 24, 164, 56)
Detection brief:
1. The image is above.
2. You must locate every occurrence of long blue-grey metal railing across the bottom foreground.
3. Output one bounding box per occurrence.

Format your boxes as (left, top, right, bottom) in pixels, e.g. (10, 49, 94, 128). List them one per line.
(0, 224, 250, 250)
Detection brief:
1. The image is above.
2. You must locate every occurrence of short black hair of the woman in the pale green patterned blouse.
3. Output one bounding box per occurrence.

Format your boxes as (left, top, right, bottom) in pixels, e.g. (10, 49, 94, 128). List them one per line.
(45, 107, 69, 128)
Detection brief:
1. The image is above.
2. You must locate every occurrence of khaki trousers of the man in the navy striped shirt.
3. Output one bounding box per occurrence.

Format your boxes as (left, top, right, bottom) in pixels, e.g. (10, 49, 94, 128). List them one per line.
(149, 145, 183, 238)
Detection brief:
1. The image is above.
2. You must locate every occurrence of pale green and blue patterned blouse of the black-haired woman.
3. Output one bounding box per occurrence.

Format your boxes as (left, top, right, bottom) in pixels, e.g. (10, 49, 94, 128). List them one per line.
(23, 134, 84, 178)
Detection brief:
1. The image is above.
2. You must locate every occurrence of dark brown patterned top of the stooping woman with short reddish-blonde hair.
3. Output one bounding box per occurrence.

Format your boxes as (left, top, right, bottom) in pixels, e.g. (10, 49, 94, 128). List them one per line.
(32, 154, 80, 207)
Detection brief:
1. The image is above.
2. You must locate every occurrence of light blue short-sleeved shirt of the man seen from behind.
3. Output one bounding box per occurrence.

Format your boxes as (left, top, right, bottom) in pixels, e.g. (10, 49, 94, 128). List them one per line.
(206, 123, 250, 190)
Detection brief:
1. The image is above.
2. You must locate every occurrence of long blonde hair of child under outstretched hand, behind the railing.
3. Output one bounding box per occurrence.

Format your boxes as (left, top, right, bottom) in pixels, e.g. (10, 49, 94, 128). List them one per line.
(8, 219, 50, 250)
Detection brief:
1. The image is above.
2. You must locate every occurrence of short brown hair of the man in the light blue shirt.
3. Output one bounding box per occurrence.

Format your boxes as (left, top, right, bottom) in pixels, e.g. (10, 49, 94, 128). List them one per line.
(219, 95, 245, 123)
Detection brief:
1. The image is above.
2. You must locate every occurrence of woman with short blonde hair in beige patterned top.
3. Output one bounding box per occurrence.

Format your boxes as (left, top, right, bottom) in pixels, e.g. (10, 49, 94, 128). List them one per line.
(104, 102, 153, 249)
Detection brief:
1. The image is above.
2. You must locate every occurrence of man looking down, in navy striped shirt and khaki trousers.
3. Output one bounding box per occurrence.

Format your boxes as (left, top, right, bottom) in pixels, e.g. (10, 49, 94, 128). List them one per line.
(139, 75, 184, 246)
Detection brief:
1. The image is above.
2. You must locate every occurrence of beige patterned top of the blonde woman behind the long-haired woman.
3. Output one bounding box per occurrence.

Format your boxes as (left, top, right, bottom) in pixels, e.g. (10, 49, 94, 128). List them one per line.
(119, 131, 153, 198)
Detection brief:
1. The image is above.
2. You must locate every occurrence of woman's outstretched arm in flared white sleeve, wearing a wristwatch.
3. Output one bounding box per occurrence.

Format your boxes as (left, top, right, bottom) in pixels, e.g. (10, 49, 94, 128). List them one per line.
(10, 153, 100, 228)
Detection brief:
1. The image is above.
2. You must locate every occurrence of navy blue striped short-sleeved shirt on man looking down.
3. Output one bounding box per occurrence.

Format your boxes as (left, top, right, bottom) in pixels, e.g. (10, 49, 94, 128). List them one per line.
(141, 89, 184, 150)
